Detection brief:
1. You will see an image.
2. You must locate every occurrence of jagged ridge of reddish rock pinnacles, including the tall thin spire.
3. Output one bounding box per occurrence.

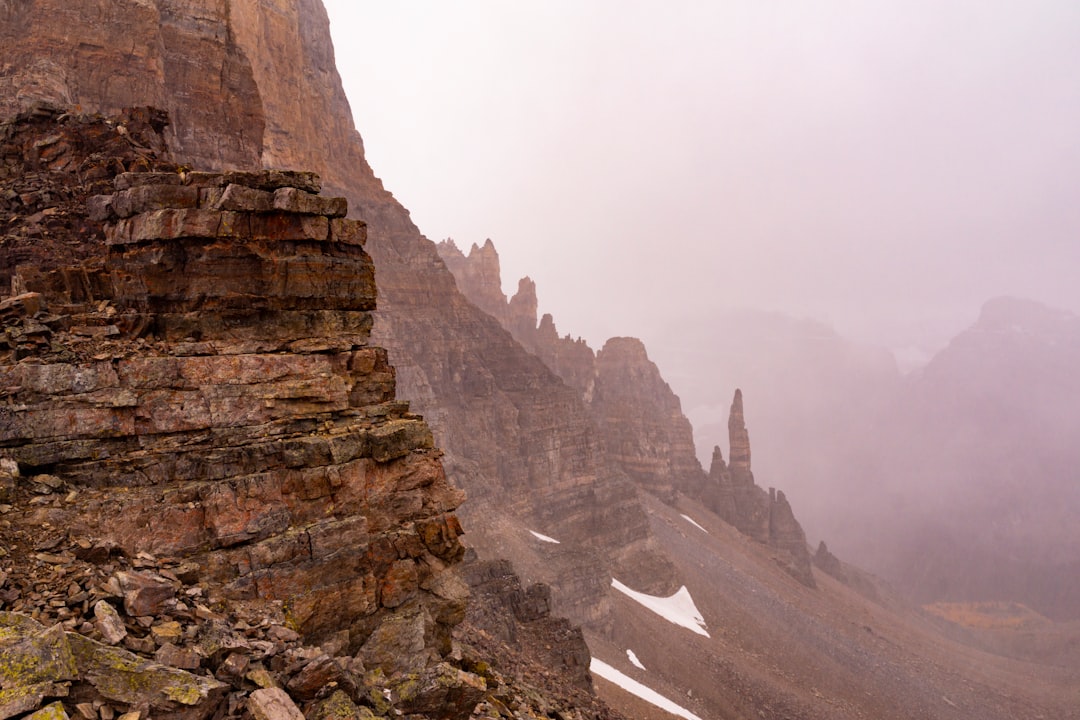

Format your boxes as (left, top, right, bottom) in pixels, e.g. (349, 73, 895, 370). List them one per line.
(437, 240, 814, 587)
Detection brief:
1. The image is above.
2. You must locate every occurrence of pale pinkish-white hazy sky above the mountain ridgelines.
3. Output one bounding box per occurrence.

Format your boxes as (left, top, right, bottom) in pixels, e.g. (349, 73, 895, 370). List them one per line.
(326, 0, 1080, 356)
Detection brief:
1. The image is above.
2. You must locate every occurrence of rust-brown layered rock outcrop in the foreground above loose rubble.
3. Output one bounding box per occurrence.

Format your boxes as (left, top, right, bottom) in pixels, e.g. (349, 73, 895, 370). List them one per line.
(0, 110, 467, 670)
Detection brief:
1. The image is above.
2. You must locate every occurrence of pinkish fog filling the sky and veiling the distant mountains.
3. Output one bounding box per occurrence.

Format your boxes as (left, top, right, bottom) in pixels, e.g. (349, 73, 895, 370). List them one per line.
(326, 0, 1080, 617)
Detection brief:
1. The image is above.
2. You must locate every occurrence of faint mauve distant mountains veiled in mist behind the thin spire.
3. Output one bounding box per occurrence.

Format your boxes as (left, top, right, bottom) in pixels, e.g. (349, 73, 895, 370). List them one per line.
(643, 298, 1080, 619)
